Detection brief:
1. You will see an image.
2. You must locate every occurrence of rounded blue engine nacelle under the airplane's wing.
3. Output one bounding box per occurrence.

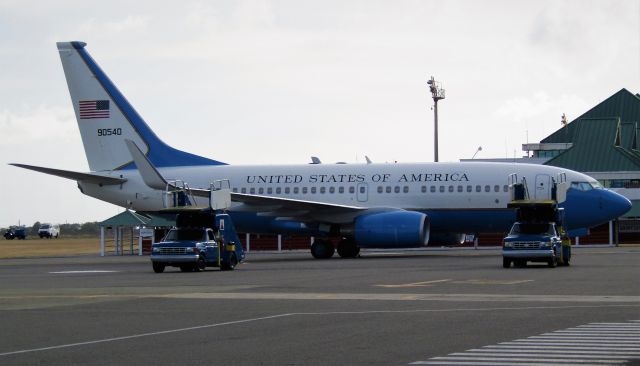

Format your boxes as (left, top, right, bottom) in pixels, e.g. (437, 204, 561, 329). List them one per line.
(353, 211, 429, 248)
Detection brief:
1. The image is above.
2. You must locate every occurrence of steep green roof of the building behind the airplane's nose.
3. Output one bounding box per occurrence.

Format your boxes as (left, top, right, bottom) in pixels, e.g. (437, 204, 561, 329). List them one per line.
(541, 89, 640, 172)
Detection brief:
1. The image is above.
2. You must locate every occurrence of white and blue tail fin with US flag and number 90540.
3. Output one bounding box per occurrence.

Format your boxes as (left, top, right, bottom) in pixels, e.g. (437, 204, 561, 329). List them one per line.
(57, 42, 224, 171)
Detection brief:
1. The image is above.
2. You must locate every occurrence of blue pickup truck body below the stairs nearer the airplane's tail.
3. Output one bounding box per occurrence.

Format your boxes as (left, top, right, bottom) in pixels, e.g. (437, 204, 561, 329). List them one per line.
(151, 227, 243, 273)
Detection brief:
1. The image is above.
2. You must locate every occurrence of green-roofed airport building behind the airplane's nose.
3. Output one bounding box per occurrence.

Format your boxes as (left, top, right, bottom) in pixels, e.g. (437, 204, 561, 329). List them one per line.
(522, 89, 640, 243)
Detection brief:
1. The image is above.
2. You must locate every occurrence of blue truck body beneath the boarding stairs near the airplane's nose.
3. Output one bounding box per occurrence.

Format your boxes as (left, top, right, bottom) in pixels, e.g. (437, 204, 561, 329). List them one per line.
(502, 222, 568, 268)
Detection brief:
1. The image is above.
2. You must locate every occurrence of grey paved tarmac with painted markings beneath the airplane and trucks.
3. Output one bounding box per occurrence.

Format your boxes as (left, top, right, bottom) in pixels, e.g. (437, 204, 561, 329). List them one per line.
(0, 247, 640, 365)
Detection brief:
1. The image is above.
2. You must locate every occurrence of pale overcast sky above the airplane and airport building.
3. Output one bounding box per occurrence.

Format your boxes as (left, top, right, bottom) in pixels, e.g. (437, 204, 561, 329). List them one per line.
(0, 0, 640, 227)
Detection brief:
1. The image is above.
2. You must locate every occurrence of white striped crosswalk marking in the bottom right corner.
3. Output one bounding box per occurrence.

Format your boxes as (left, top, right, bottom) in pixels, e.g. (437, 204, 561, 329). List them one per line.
(411, 321, 640, 366)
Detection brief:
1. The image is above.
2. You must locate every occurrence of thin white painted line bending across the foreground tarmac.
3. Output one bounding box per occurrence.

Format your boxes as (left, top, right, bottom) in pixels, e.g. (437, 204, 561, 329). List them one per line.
(0, 305, 636, 356)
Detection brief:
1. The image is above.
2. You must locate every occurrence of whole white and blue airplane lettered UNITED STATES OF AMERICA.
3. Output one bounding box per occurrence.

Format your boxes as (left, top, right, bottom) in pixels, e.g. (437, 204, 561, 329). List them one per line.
(13, 42, 631, 258)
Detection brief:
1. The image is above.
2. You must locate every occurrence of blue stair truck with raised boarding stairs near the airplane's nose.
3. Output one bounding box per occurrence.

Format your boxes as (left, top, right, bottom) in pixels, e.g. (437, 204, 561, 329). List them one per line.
(502, 176, 571, 268)
